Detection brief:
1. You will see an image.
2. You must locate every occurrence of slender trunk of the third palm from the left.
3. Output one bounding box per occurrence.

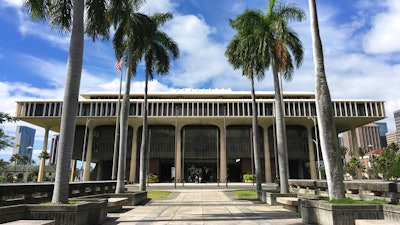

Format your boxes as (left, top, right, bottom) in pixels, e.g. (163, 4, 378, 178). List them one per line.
(139, 73, 149, 191)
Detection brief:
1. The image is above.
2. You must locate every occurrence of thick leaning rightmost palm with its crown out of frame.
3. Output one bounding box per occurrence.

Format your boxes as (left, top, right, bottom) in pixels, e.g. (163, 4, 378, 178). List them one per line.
(308, 0, 345, 199)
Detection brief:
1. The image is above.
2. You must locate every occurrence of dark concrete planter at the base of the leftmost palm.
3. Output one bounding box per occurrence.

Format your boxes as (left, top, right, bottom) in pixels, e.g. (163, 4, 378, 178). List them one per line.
(25, 200, 107, 225)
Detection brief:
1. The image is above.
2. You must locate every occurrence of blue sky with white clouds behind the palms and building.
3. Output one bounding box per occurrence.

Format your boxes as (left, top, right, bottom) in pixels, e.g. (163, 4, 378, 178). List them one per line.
(0, 0, 400, 160)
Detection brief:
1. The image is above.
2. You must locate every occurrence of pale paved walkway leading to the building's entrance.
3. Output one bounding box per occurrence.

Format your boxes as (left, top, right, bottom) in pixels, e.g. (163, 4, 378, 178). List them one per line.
(106, 183, 304, 225)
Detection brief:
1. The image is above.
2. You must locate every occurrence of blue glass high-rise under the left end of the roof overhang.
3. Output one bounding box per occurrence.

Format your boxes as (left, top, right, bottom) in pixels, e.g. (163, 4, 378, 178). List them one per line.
(13, 126, 36, 162)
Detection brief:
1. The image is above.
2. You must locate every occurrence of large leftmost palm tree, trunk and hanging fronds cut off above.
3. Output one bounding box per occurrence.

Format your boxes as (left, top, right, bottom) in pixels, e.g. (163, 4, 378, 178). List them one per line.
(24, 0, 109, 203)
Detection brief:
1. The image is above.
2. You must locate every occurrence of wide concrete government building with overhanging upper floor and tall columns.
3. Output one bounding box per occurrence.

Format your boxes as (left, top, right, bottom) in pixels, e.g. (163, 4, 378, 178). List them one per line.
(15, 89, 386, 183)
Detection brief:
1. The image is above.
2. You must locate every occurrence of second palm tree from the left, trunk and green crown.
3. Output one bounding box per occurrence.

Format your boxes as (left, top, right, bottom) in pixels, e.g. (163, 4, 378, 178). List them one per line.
(109, 0, 153, 193)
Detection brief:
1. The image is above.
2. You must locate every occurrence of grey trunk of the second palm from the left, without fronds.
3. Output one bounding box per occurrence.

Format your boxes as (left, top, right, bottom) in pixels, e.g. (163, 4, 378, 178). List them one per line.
(115, 48, 132, 194)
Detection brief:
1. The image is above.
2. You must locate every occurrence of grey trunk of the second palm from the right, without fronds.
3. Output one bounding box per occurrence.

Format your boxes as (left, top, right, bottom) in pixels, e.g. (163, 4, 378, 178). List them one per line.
(272, 62, 289, 193)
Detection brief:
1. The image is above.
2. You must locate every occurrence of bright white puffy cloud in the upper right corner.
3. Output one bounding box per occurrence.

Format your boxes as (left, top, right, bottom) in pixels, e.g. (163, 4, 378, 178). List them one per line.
(363, 0, 400, 54)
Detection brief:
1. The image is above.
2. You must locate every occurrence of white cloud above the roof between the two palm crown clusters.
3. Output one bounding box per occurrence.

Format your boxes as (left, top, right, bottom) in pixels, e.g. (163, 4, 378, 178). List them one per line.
(166, 15, 233, 87)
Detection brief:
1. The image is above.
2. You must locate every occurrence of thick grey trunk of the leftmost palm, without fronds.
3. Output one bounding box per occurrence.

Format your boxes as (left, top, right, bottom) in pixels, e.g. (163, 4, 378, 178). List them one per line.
(52, 0, 84, 203)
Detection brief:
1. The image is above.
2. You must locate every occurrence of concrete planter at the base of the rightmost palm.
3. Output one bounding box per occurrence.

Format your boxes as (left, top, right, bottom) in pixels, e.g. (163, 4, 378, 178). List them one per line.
(300, 199, 384, 225)
